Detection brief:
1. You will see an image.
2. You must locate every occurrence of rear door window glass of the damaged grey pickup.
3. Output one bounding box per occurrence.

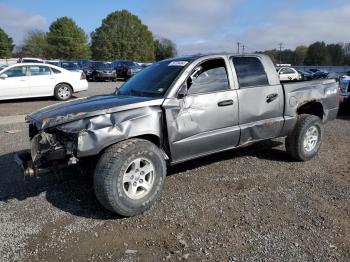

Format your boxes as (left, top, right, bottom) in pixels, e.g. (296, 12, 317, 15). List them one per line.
(232, 57, 269, 88)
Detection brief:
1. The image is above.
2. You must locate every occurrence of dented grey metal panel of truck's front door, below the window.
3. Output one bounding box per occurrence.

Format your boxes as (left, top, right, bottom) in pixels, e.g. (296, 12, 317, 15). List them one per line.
(163, 90, 240, 162)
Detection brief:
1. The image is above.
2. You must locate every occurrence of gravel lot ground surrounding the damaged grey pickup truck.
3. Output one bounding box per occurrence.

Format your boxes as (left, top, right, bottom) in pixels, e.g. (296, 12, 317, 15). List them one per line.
(0, 83, 350, 261)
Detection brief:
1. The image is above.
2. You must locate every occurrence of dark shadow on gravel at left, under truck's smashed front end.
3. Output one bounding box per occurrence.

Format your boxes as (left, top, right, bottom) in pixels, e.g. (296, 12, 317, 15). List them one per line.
(0, 151, 120, 219)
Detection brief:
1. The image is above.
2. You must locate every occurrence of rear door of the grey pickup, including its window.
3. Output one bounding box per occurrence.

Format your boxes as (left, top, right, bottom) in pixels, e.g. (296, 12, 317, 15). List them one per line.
(231, 57, 284, 145)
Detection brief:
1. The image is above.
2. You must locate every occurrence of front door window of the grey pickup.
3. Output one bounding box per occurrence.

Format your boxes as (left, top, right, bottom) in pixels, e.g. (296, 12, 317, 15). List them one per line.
(187, 59, 229, 94)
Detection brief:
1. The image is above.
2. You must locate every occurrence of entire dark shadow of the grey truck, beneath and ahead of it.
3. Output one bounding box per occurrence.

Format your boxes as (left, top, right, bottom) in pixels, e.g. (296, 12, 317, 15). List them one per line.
(0, 140, 293, 220)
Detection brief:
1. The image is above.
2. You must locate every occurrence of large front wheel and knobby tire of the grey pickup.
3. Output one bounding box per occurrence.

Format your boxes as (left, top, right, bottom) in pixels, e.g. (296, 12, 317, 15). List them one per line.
(94, 139, 166, 217)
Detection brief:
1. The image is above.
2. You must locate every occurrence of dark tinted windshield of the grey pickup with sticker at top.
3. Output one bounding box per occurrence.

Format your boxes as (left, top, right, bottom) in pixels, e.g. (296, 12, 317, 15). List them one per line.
(118, 61, 188, 97)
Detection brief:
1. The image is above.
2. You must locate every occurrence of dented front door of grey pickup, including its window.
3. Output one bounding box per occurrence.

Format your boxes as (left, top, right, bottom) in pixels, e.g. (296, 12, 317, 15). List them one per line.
(163, 58, 239, 162)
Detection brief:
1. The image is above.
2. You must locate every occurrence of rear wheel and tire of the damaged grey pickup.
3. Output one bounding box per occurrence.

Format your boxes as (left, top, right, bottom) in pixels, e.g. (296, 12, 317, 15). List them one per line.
(285, 114, 323, 161)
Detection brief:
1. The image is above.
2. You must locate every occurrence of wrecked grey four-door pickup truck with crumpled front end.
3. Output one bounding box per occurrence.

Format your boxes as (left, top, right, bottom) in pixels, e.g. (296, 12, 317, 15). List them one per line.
(17, 54, 339, 216)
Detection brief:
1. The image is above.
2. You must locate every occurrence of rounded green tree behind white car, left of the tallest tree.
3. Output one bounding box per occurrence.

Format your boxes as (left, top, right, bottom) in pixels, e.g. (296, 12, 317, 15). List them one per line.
(47, 17, 90, 59)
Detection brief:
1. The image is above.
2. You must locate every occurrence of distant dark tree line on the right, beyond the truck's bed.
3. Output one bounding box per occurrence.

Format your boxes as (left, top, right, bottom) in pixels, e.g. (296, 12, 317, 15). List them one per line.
(257, 42, 350, 66)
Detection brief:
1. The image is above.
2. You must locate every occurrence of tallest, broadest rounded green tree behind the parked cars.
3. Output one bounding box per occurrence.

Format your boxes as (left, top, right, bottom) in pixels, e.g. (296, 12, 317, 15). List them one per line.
(91, 10, 154, 62)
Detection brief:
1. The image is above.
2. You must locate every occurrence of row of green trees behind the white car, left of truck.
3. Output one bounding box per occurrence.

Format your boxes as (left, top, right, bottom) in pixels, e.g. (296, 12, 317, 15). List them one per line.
(0, 10, 177, 62)
